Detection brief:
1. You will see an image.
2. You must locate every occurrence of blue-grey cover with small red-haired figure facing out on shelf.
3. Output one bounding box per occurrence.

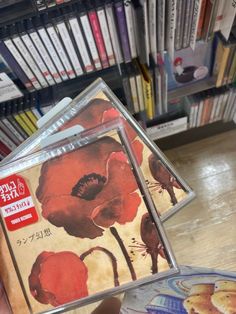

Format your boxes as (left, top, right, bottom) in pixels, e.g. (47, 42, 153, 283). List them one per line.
(164, 41, 212, 90)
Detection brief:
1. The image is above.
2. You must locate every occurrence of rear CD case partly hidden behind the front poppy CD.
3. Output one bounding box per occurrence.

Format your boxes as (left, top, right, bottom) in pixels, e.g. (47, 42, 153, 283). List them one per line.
(3, 79, 195, 221)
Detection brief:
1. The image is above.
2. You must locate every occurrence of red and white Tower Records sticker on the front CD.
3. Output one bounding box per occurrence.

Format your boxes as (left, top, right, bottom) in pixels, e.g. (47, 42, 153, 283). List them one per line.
(0, 175, 38, 231)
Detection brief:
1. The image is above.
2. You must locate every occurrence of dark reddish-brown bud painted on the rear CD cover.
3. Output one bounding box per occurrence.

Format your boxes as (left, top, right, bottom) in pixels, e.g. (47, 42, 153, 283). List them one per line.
(147, 154, 182, 205)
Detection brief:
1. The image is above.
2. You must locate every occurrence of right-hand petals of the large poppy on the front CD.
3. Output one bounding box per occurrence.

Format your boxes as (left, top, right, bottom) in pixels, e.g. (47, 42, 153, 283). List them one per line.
(91, 152, 141, 228)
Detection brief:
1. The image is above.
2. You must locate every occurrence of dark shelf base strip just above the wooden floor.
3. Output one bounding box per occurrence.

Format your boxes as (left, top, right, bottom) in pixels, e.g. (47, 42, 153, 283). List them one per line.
(155, 121, 236, 150)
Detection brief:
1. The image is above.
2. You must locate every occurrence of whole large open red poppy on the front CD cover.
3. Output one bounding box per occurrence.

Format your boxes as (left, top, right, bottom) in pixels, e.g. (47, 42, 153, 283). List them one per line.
(36, 137, 141, 239)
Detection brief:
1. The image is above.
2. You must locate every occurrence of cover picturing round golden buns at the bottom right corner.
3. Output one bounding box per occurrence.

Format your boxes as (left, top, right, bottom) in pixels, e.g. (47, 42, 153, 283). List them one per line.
(121, 266, 236, 314)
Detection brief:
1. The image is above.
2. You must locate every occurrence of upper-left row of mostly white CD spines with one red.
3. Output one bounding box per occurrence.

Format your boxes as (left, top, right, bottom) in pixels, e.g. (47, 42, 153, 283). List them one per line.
(0, 2, 131, 91)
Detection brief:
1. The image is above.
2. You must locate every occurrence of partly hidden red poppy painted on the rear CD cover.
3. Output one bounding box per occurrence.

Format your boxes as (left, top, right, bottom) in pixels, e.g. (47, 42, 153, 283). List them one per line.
(61, 98, 143, 165)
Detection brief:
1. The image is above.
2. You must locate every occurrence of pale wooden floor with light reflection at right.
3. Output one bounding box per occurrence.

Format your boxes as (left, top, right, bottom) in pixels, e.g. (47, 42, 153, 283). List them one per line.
(165, 130, 236, 271)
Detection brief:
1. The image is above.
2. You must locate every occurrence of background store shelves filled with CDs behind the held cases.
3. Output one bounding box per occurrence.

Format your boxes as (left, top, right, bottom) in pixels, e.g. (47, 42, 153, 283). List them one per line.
(0, 0, 236, 162)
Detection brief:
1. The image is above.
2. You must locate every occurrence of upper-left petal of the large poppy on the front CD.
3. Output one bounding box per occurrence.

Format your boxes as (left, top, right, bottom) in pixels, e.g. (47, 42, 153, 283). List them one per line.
(36, 137, 122, 202)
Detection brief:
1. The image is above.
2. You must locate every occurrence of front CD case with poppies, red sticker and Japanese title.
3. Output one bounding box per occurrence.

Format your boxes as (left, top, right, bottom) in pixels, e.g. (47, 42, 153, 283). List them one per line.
(0, 119, 178, 313)
